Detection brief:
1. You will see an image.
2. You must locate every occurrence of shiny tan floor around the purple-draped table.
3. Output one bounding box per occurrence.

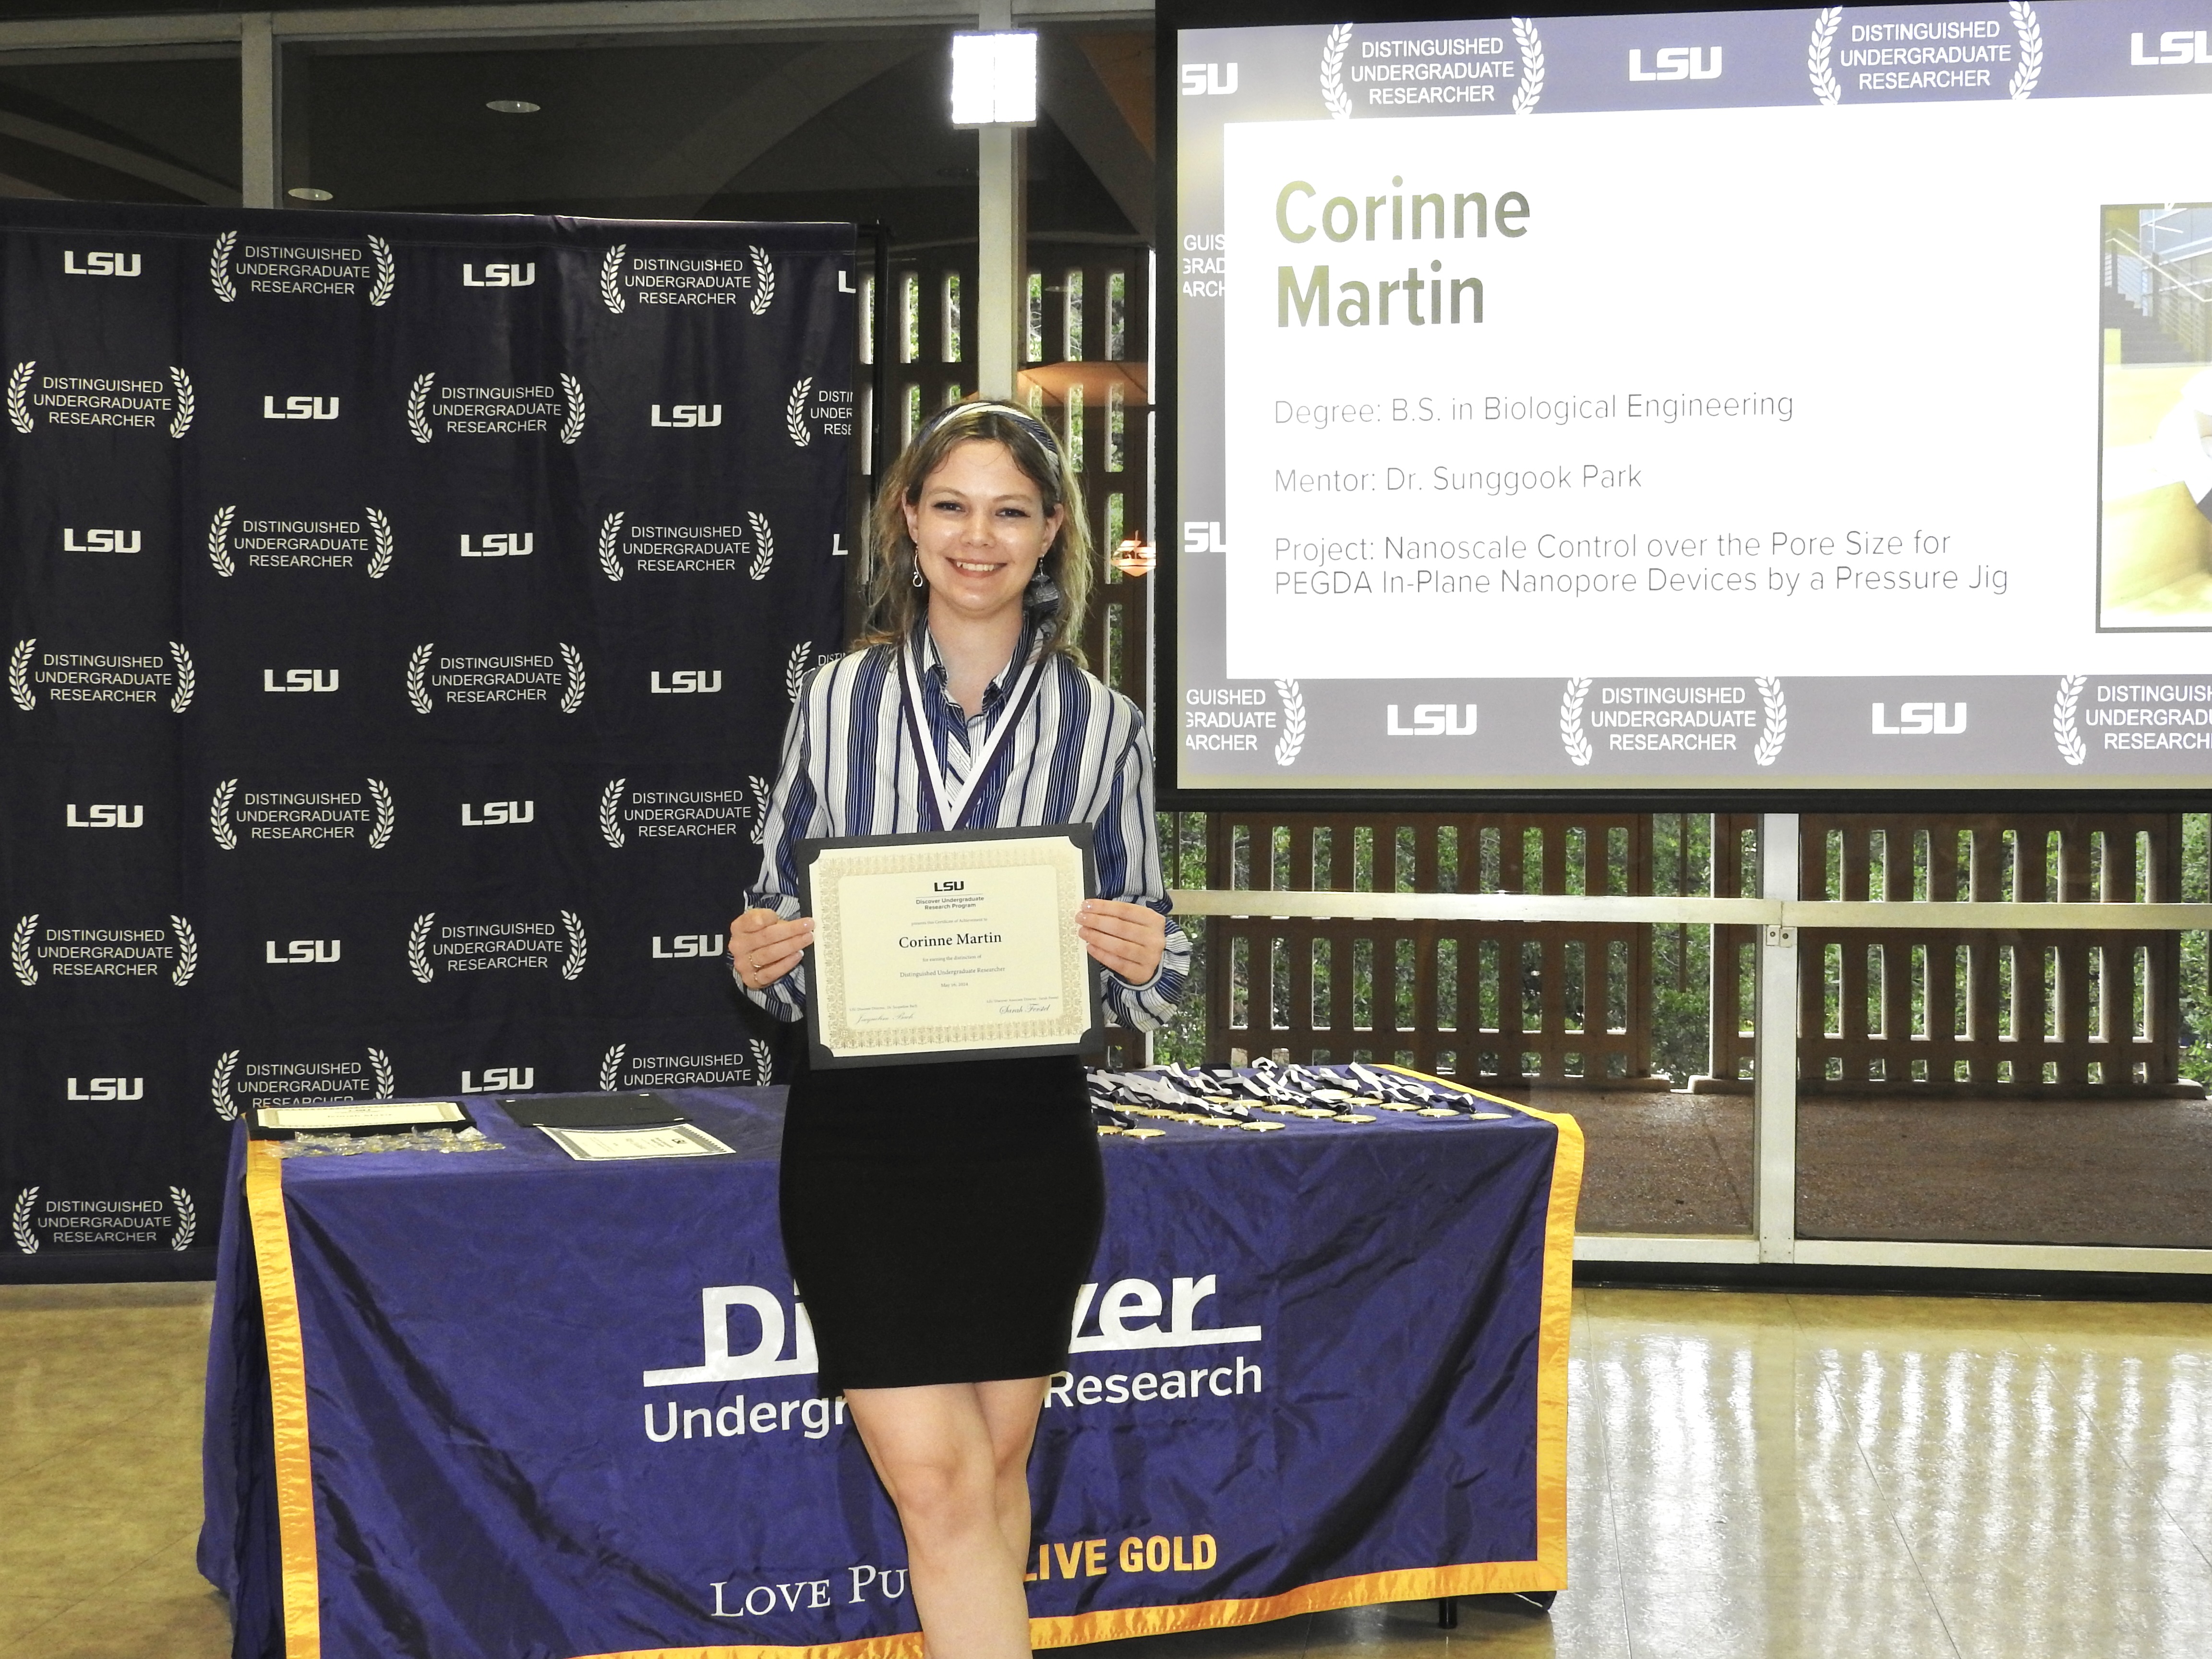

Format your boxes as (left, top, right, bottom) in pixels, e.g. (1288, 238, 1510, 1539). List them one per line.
(0, 1287, 2212, 1659)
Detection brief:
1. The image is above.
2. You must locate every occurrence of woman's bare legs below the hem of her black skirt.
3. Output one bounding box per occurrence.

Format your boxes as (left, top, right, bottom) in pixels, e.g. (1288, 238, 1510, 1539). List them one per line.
(845, 1378, 1044, 1659)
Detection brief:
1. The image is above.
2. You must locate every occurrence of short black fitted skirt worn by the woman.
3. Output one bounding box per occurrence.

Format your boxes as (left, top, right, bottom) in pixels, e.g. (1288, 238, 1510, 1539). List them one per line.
(781, 1058, 1106, 1394)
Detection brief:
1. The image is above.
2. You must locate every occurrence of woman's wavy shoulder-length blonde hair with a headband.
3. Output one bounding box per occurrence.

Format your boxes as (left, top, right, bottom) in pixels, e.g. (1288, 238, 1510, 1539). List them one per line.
(854, 400, 1091, 668)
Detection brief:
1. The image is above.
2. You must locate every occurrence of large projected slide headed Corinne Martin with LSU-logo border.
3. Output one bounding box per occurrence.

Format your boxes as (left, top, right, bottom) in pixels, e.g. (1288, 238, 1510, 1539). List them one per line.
(1161, 0, 2212, 790)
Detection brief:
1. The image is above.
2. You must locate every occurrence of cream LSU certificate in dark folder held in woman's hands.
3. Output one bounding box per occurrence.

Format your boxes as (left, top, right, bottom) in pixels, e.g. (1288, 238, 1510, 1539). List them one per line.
(798, 823, 1104, 1066)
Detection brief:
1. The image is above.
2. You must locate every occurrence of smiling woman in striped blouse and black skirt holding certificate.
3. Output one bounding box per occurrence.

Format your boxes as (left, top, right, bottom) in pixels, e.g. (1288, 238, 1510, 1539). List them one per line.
(730, 403, 1190, 1659)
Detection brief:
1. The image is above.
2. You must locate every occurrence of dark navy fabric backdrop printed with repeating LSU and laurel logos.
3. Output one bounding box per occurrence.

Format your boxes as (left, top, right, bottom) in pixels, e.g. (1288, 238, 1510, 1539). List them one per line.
(0, 201, 858, 1278)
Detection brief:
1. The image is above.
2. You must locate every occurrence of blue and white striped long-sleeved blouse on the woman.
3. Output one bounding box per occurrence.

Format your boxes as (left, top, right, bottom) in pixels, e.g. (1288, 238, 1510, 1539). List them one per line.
(745, 626, 1190, 1031)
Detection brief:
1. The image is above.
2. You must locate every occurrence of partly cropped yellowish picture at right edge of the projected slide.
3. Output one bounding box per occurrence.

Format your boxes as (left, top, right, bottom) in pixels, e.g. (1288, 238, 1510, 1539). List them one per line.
(2097, 201, 2212, 630)
